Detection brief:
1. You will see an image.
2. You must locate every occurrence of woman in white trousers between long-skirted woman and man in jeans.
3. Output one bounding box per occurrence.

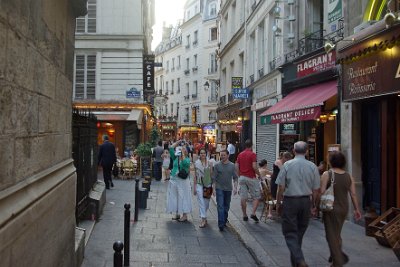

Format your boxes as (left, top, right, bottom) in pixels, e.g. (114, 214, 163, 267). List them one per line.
(193, 148, 212, 228)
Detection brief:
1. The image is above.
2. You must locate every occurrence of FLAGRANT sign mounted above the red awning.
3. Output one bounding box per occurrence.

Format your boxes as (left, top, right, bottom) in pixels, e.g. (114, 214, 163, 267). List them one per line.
(296, 51, 336, 78)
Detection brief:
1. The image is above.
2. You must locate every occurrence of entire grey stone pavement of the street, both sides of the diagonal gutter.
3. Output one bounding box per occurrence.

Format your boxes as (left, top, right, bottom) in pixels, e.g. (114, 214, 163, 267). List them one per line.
(82, 176, 399, 267)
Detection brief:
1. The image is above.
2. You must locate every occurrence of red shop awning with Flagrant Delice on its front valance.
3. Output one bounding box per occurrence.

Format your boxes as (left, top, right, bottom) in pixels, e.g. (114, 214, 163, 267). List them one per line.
(260, 80, 337, 124)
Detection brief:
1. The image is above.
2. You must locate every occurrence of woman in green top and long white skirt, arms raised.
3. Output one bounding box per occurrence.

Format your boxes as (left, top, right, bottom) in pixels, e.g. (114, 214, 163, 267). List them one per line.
(167, 140, 192, 222)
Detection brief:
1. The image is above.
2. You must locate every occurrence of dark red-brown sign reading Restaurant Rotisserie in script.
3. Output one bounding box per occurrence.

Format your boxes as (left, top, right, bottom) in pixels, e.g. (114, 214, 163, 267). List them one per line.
(343, 46, 400, 101)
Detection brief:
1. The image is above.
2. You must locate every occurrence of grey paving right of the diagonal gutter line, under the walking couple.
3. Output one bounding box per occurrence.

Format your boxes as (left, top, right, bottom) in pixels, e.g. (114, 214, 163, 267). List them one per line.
(229, 196, 400, 267)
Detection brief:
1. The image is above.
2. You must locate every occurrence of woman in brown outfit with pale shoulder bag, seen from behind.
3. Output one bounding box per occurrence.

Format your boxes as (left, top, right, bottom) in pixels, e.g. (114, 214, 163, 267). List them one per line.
(321, 151, 361, 267)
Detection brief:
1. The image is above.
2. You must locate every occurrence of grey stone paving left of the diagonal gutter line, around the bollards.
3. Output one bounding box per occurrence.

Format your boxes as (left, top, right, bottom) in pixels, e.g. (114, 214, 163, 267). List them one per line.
(82, 180, 257, 267)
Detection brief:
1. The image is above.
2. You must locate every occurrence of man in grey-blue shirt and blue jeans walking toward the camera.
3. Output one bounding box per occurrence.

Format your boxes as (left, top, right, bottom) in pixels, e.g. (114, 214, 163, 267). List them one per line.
(212, 150, 238, 231)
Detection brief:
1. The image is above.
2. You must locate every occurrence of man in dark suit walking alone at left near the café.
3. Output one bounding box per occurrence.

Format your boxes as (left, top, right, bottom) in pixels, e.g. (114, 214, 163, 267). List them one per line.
(98, 135, 117, 189)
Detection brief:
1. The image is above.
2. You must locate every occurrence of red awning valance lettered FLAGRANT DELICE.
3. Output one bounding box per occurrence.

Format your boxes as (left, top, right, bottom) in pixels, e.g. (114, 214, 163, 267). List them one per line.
(270, 106, 321, 124)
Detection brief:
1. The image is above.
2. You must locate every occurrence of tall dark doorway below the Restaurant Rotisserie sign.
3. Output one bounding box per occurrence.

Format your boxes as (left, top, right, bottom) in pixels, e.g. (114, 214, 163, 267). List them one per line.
(361, 102, 381, 213)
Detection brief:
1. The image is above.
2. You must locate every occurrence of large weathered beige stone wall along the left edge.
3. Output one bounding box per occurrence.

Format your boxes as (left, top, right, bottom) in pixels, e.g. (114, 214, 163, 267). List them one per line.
(0, 0, 85, 266)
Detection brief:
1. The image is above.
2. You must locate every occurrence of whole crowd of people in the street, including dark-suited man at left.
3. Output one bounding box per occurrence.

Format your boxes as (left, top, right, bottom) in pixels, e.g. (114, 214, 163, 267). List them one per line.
(99, 136, 361, 267)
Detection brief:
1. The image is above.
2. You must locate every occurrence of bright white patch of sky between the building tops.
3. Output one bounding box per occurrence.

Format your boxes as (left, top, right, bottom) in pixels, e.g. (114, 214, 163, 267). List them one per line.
(151, 0, 186, 51)
